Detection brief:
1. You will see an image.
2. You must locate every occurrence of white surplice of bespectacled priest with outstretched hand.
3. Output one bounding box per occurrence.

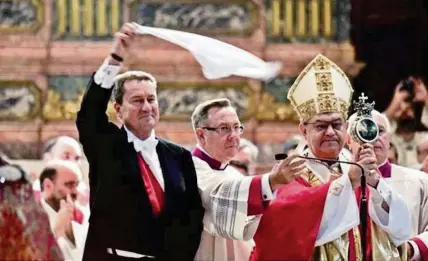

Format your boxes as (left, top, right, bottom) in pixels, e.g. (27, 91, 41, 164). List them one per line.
(193, 157, 260, 261)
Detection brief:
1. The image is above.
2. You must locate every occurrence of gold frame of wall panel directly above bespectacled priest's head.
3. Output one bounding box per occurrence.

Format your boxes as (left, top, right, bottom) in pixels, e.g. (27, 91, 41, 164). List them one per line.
(158, 82, 257, 121)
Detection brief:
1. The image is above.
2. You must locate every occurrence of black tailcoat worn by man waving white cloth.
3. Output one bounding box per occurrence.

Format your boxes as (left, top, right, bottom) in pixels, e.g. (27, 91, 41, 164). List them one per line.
(77, 77, 204, 261)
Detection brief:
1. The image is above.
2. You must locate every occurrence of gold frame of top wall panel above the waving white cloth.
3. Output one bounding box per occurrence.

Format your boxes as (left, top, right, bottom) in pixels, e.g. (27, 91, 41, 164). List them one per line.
(127, 0, 260, 35)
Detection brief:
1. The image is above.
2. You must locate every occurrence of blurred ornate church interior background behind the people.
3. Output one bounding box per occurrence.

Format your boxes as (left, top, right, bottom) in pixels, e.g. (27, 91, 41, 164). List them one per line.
(0, 0, 428, 175)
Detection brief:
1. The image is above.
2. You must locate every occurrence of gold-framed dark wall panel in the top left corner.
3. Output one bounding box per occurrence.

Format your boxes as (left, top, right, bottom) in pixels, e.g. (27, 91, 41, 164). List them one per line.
(0, 0, 45, 32)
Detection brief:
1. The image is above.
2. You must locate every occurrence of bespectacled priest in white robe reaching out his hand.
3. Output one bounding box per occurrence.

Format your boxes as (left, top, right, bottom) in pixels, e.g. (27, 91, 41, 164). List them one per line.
(192, 99, 303, 261)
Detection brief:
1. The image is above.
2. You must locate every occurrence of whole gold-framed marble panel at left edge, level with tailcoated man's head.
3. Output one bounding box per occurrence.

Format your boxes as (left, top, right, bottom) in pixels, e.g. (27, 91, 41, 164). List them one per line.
(0, 81, 40, 120)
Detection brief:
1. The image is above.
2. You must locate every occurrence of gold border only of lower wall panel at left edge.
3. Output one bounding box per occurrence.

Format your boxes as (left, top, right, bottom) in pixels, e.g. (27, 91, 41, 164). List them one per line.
(0, 80, 42, 121)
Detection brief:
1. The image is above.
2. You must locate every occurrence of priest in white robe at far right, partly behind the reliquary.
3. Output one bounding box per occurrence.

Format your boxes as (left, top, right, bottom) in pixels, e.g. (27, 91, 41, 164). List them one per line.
(348, 110, 428, 261)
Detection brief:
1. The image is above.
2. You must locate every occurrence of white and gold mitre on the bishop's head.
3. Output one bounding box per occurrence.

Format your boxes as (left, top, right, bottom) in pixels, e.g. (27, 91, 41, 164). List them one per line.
(288, 54, 354, 122)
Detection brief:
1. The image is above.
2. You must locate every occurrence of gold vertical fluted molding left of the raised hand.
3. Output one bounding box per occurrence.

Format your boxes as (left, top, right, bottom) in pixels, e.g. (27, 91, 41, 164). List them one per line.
(52, 0, 124, 40)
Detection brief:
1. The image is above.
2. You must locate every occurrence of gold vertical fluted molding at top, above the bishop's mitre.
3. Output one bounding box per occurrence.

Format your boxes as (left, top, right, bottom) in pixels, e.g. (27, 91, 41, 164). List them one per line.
(265, 0, 351, 43)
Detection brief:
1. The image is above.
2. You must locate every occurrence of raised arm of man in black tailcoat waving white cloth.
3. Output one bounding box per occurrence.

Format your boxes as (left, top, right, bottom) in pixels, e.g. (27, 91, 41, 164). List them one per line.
(76, 24, 135, 193)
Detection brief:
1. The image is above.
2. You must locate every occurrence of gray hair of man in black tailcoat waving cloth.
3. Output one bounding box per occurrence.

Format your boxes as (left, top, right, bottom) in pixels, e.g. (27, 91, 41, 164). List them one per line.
(113, 71, 157, 104)
